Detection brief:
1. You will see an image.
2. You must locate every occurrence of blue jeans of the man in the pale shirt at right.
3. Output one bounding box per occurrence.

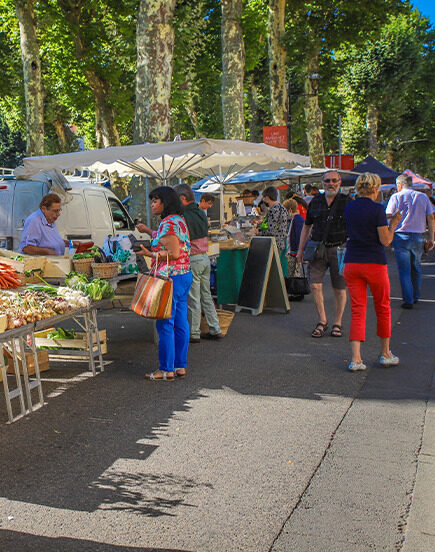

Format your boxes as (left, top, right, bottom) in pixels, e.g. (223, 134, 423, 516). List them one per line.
(393, 232, 424, 304)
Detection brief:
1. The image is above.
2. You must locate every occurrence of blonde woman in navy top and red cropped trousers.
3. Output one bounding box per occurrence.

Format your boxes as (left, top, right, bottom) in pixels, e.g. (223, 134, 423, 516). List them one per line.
(344, 173, 401, 372)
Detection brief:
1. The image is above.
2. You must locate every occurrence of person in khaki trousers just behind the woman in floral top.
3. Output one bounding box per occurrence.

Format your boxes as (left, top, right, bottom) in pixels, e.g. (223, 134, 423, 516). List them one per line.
(174, 184, 223, 343)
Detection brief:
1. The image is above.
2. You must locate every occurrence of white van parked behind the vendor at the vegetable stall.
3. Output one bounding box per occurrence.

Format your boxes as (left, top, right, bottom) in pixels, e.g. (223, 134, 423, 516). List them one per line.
(0, 176, 150, 251)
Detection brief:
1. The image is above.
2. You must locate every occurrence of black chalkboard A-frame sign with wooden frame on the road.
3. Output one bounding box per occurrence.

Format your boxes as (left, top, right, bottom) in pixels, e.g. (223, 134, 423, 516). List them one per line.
(236, 236, 290, 315)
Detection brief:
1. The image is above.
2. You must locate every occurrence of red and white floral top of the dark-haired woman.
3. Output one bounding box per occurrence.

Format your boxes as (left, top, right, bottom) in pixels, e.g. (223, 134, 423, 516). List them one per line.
(151, 215, 190, 277)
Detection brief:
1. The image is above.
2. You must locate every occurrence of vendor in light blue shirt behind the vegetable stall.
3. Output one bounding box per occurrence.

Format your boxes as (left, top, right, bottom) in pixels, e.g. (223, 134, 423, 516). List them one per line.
(19, 194, 68, 255)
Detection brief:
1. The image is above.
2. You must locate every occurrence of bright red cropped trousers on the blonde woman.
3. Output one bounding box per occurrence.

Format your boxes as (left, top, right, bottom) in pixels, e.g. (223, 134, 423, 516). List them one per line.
(344, 263, 391, 341)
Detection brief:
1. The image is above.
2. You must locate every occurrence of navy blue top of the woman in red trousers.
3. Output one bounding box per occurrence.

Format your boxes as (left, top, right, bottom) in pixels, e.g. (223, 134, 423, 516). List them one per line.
(344, 197, 388, 264)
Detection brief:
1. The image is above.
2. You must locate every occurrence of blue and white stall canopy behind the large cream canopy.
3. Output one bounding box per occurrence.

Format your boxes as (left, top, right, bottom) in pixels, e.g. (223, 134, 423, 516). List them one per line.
(192, 166, 357, 193)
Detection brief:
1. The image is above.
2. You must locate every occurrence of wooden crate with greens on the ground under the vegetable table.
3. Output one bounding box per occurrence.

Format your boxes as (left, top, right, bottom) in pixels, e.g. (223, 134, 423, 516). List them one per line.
(35, 328, 107, 359)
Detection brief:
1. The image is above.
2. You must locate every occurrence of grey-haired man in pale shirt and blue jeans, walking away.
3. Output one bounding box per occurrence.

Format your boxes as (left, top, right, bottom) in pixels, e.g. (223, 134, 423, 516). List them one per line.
(386, 174, 435, 309)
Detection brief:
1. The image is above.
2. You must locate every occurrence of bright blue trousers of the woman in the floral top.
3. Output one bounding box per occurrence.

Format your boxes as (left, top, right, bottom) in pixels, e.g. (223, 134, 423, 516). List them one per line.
(156, 272, 192, 372)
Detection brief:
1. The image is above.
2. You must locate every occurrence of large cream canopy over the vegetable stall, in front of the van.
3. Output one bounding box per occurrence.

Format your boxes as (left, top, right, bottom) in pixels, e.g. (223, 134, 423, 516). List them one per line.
(15, 138, 310, 182)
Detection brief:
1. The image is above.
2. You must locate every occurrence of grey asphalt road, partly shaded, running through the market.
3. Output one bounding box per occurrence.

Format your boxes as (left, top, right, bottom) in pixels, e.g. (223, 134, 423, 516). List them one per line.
(0, 250, 435, 552)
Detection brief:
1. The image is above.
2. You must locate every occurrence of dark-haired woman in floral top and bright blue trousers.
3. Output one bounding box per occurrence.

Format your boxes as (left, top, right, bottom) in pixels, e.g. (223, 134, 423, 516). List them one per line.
(139, 186, 192, 381)
